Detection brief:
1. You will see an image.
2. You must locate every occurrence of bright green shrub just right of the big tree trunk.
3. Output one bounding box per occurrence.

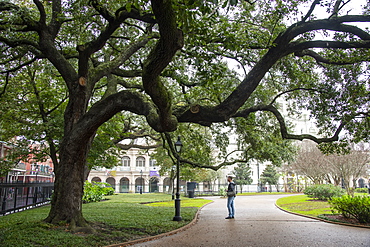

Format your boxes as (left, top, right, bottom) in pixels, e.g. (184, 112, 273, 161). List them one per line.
(82, 181, 114, 203)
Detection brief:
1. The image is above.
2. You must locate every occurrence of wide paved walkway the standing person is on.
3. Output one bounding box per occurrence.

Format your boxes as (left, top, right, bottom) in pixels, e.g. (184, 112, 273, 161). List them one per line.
(134, 195, 370, 247)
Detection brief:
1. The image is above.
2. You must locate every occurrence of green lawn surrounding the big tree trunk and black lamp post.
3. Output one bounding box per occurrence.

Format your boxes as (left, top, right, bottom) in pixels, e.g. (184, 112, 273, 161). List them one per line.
(0, 194, 209, 247)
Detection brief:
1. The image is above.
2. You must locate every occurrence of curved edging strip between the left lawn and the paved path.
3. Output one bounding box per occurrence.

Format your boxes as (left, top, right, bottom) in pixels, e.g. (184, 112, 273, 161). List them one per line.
(105, 201, 213, 247)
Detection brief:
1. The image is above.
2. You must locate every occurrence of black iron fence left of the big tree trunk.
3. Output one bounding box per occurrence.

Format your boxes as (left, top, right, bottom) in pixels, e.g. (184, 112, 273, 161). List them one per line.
(0, 183, 54, 215)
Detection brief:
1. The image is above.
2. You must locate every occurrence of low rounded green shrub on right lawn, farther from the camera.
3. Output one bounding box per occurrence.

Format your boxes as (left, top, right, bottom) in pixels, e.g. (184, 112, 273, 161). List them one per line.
(304, 184, 345, 201)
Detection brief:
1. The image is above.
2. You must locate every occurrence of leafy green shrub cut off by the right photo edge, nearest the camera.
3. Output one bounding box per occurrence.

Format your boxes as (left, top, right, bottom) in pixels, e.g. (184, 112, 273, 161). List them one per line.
(328, 195, 370, 223)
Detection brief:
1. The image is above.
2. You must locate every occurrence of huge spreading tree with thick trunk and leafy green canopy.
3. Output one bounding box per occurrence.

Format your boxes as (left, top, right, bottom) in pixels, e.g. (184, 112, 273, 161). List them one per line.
(0, 0, 370, 227)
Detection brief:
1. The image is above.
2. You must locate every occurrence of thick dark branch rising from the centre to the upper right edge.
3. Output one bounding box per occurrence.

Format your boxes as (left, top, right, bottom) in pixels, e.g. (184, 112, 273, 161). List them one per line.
(175, 15, 370, 126)
